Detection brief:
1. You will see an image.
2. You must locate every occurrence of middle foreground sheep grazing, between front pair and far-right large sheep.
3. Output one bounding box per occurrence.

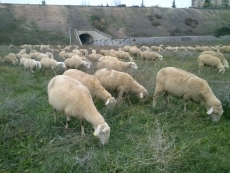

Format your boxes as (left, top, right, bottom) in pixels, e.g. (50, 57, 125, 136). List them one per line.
(94, 68, 148, 100)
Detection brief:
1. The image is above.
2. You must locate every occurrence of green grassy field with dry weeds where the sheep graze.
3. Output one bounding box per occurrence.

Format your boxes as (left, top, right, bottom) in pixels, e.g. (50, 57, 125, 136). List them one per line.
(0, 47, 230, 173)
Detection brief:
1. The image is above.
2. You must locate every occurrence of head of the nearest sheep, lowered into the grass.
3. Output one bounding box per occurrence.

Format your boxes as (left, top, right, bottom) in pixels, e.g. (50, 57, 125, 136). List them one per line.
(93, 123, 110, 145)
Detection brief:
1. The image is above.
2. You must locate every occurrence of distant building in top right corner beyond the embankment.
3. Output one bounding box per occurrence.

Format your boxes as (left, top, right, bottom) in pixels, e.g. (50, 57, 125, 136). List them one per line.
(192, 0, 230, 7)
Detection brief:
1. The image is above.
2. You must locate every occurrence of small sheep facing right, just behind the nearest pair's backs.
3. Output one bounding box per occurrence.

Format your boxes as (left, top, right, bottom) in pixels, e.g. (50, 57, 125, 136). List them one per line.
(64, 58, 92, 70)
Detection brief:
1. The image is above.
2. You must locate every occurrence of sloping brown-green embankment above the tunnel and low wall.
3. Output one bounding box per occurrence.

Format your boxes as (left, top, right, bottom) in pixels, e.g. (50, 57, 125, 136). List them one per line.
(0, 4, 230, 44)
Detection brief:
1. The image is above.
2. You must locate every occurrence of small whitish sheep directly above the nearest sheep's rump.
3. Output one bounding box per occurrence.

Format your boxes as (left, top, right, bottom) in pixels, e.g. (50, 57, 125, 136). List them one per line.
(40, 58, 66, 75)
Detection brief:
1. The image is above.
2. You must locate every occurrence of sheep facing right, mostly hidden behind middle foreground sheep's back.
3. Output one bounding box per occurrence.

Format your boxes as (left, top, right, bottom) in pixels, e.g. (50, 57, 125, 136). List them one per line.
(96, 60, 138, 71)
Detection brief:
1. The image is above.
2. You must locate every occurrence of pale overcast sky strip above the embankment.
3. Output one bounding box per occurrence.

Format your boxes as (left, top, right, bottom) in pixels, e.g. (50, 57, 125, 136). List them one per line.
(0, 0, 191, 8)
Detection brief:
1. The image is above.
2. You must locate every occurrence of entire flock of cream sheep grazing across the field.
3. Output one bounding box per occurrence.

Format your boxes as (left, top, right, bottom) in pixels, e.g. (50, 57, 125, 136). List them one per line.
(0, 45, 230, 145)
